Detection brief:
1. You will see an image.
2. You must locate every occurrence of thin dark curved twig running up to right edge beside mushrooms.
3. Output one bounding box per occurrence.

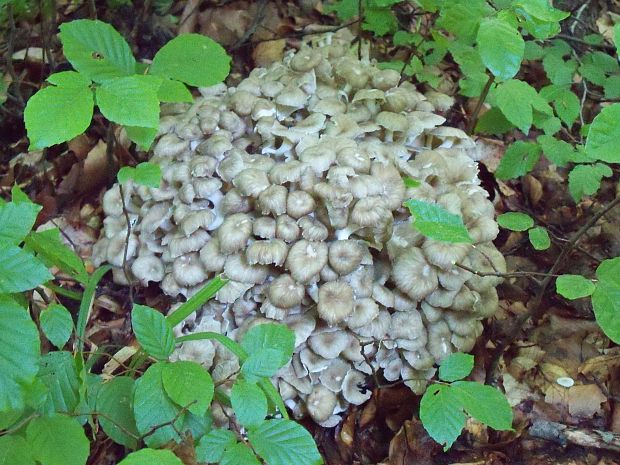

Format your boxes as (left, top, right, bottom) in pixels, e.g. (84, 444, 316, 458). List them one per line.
(485, 195, 620, 385)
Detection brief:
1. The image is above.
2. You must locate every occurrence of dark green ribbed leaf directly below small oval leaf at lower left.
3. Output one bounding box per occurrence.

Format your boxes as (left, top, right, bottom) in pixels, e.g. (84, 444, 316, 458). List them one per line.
(38, 351, 80, 414)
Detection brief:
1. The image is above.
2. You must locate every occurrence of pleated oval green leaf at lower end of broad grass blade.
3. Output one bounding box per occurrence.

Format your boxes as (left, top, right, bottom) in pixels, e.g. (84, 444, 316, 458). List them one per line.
(131, 304, 174, 360)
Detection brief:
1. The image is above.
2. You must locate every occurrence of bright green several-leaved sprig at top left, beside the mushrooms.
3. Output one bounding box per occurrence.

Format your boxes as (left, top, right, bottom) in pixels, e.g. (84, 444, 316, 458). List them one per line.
(24, 19, 230, 150)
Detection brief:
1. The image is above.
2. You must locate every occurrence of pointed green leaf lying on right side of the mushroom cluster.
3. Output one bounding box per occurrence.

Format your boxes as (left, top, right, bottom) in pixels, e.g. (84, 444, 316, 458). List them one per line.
(404, 199, 472, 243)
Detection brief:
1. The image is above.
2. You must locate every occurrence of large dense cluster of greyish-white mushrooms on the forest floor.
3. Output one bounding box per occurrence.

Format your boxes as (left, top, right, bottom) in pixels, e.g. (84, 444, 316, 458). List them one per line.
(93, 30, 505, 426)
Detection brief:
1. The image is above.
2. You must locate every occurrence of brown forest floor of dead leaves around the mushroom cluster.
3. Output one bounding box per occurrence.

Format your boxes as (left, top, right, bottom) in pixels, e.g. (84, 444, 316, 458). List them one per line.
(0, 0, 620, 465)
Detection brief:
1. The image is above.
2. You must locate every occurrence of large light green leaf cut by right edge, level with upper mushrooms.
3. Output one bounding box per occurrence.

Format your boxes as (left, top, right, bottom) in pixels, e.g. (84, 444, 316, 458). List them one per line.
(586, 103, 620, 163)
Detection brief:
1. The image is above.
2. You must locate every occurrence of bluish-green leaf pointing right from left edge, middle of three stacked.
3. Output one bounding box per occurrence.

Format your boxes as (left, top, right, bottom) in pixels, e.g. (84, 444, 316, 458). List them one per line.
(0, 245, 54, 294)
